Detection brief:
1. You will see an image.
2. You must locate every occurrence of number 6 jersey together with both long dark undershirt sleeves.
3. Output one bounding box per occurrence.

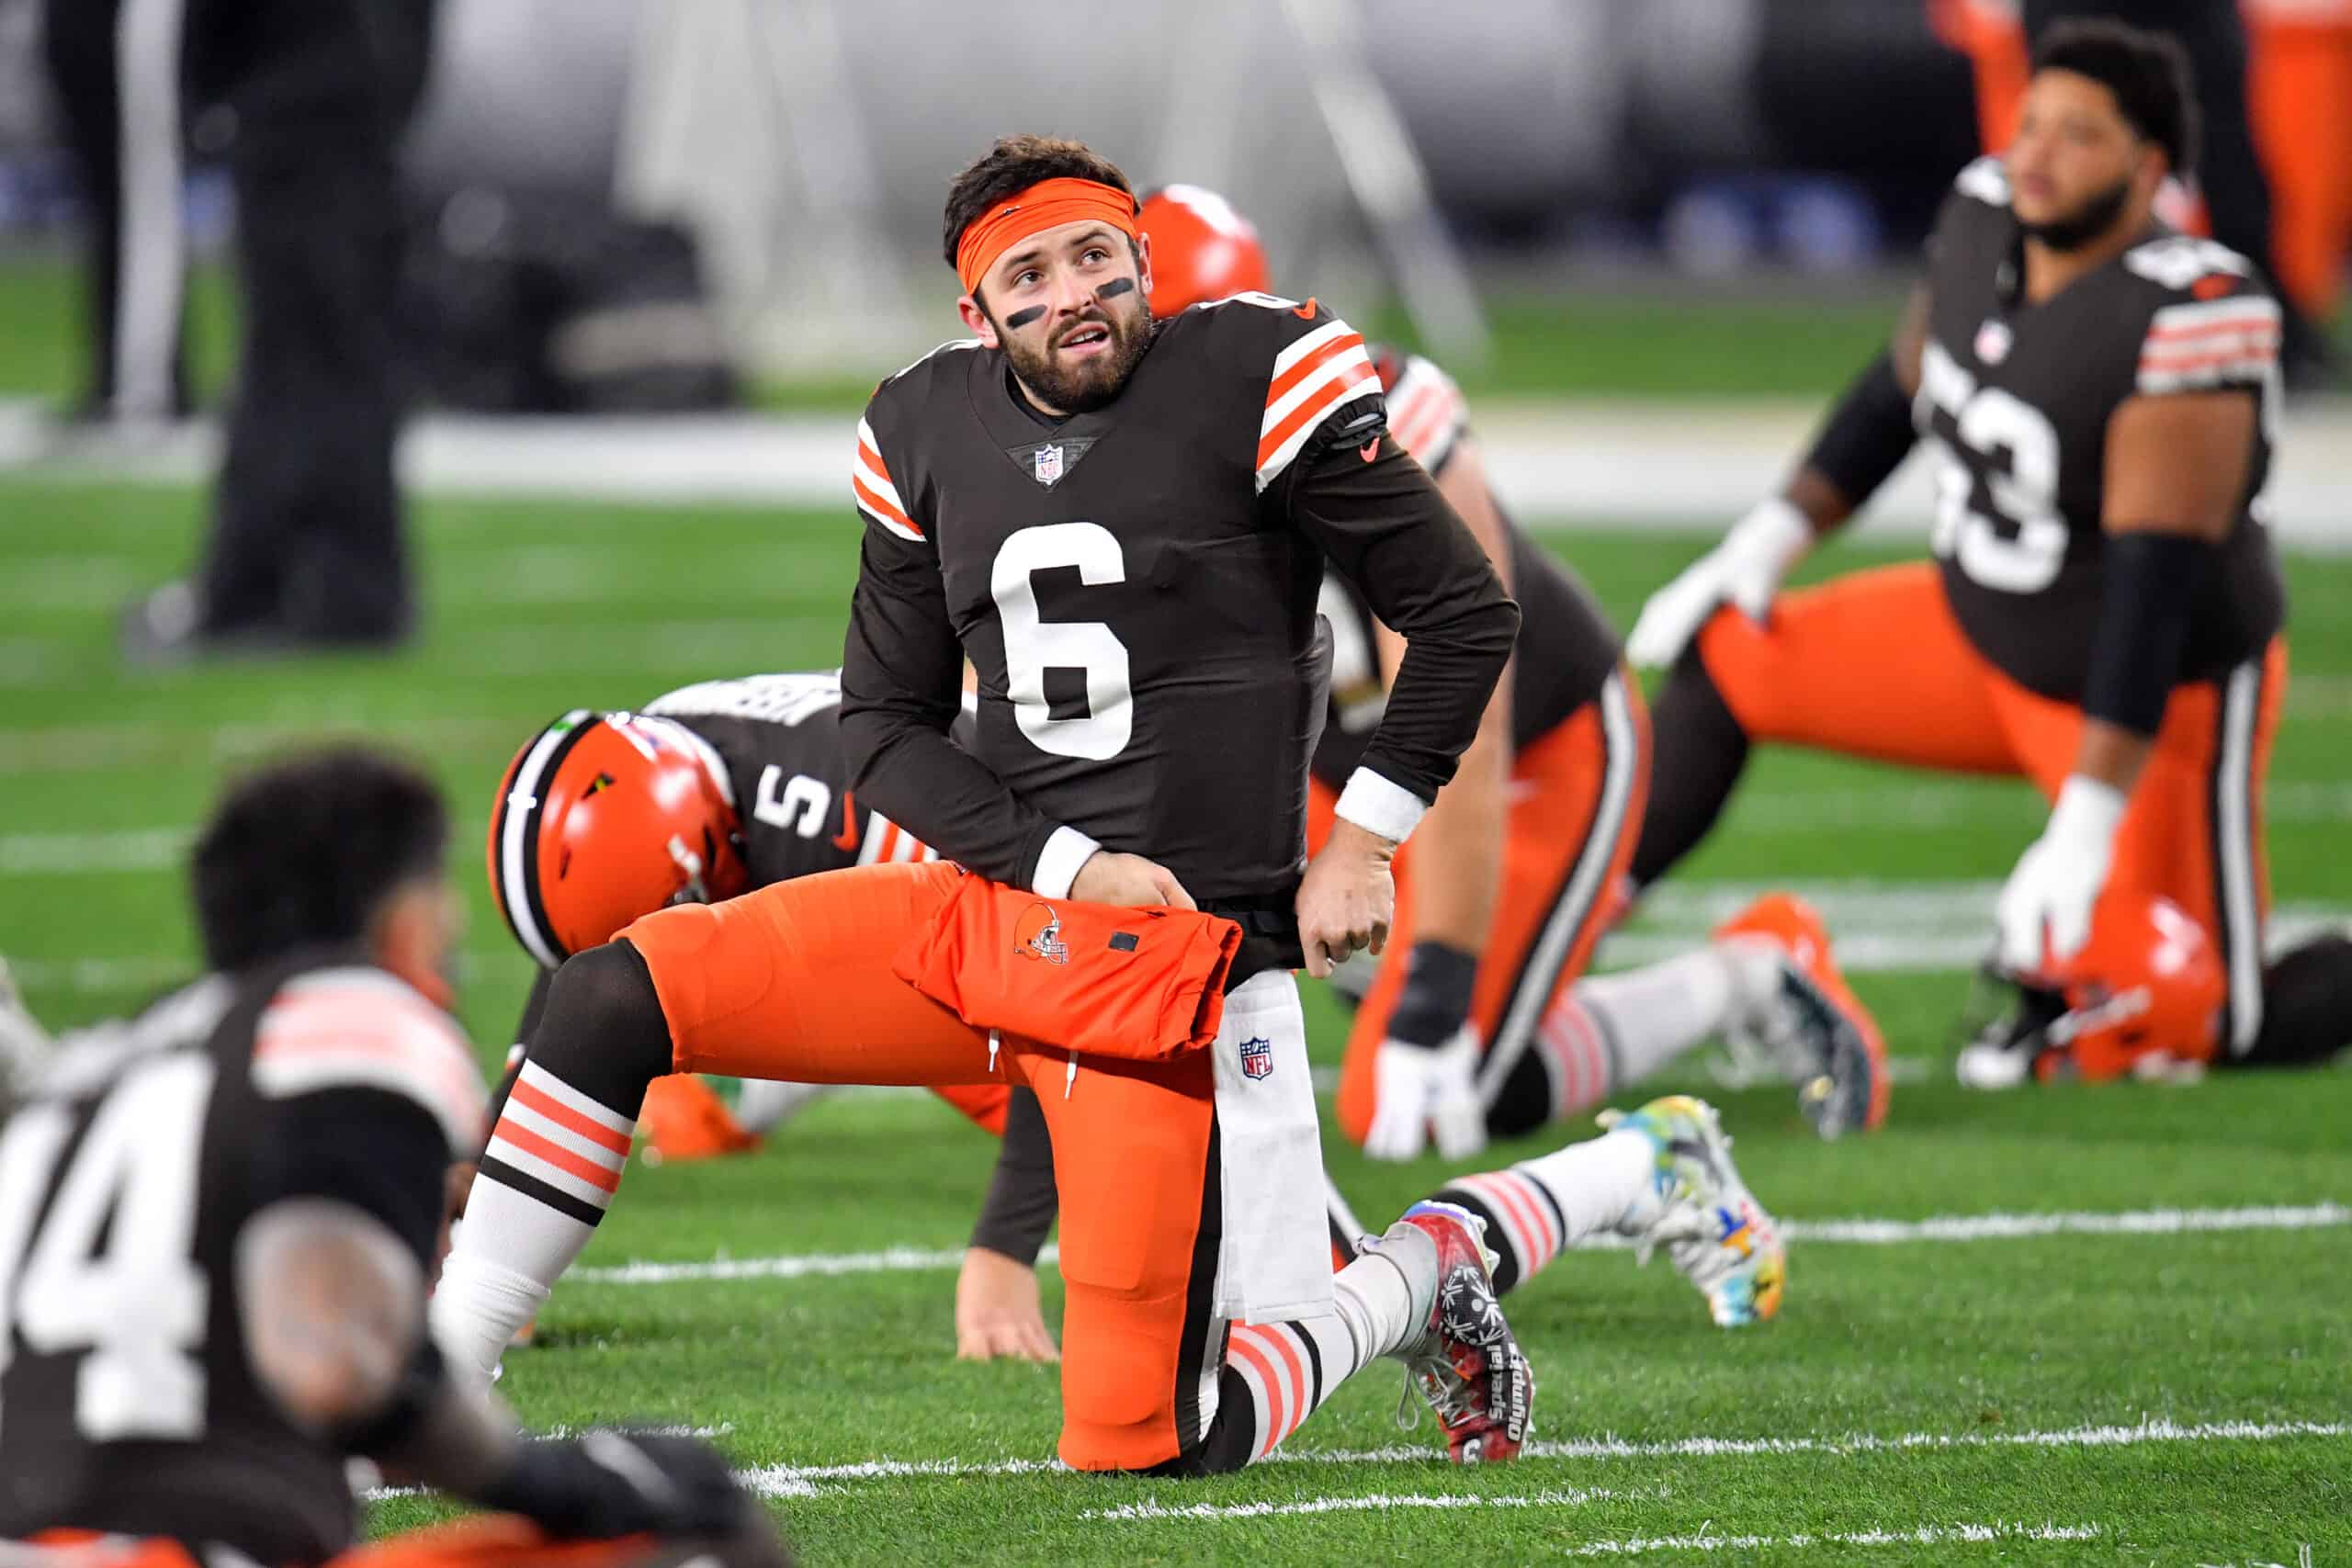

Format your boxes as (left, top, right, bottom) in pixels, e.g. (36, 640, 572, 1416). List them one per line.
(842, 294, 1517, 903)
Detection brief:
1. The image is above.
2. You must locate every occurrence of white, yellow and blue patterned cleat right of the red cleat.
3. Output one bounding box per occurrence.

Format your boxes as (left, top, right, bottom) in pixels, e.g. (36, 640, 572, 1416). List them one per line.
(1600, 1096, 1788, 1328)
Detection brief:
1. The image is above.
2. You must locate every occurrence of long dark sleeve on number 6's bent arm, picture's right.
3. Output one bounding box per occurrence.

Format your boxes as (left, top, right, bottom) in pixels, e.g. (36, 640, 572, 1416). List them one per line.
(1289, 430, 1520, 802)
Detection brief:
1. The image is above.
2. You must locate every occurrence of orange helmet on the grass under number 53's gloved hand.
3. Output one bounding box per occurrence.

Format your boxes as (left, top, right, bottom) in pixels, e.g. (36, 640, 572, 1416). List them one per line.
(1962, 891, 2227, 1086)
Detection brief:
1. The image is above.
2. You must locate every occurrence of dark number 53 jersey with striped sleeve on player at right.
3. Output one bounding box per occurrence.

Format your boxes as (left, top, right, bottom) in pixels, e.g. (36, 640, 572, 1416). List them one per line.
(1915, 157, 2286, 703)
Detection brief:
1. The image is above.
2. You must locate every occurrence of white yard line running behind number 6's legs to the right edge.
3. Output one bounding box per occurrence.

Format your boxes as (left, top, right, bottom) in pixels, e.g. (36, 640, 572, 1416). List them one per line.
(567, 1203, 2352, 1286)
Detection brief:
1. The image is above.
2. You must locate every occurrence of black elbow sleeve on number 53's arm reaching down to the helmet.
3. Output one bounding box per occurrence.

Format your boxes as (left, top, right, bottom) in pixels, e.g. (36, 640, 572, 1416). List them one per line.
(2082, 531, 2221, 736)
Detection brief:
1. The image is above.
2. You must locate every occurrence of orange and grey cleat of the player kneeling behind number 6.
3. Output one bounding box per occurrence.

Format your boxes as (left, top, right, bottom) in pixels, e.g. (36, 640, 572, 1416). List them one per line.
(1714, 894, 1894, 1138)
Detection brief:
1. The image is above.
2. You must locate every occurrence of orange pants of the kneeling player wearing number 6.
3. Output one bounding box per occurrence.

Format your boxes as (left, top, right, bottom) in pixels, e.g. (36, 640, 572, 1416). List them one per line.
(621, 861, 1216, 1470)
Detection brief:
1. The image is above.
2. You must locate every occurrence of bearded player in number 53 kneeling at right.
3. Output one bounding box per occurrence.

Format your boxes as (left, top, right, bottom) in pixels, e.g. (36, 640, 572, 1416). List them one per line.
(1630, 24, 2352, 1086)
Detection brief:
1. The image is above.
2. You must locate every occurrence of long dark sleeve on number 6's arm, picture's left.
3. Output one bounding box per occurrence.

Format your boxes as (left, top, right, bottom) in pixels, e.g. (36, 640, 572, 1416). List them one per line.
(840, 526, 1058, 886)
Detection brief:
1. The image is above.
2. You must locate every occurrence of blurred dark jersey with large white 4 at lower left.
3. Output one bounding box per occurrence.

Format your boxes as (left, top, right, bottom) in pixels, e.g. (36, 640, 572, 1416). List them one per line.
(0, 954, 484, 1563)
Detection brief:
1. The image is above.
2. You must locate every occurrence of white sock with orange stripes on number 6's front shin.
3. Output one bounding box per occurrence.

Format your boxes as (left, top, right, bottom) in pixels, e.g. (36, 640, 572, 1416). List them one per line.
(430, 1060, 638, 1375)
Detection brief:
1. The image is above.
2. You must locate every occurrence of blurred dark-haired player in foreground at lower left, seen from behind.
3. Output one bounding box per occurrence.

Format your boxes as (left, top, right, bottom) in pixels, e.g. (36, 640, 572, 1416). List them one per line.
(0, 752, 781, 1568)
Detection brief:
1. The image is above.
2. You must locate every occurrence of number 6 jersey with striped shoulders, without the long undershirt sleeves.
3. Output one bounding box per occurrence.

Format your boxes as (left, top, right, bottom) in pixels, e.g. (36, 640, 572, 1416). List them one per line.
(844, 294, 1404, 900)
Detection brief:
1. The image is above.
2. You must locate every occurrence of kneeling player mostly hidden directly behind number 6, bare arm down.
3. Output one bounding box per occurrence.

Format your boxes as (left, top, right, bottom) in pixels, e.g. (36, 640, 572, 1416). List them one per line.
(1143, 186, 1889, 1159)
